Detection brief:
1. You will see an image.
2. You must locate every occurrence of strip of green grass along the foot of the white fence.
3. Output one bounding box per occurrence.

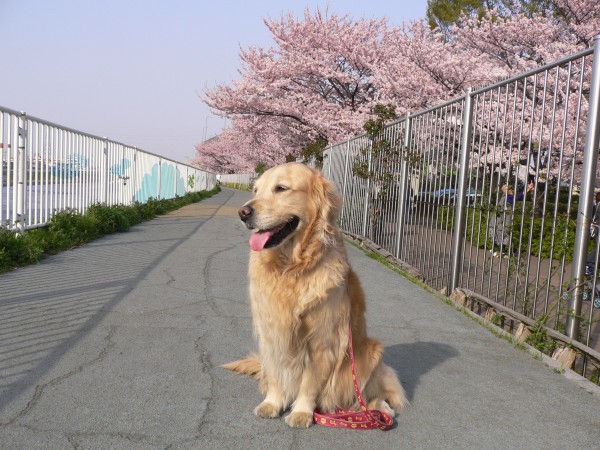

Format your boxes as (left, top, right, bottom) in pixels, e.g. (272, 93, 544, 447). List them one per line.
(0, 187, 221, 273)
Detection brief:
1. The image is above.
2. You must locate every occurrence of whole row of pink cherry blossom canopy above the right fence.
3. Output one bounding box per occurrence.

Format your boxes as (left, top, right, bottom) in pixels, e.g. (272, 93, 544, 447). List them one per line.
(196, 0, 600, 171)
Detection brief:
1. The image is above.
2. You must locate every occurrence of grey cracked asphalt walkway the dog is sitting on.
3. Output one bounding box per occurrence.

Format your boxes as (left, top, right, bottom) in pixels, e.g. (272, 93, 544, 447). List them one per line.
(0, 189, 600, 449)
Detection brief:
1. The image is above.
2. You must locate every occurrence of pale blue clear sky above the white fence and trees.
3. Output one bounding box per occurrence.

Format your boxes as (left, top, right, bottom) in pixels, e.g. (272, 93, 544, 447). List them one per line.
(0, 0, 427, 163)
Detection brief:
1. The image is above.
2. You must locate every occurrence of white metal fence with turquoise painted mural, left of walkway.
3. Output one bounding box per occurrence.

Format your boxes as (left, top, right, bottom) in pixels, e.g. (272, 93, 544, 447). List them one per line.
(0, 107, 217, 232)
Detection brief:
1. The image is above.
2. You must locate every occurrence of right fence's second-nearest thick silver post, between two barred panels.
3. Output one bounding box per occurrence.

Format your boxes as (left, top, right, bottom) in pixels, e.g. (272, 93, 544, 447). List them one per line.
(447, 88, 473, 295)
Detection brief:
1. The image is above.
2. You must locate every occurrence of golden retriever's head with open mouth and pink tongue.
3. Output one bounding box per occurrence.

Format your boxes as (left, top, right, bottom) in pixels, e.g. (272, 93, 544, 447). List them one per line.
(239, 163, 341, 251)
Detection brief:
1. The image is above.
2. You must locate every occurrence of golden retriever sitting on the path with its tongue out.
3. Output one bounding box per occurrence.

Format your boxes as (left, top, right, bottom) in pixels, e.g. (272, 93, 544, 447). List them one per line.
(223, 163, 408, 428)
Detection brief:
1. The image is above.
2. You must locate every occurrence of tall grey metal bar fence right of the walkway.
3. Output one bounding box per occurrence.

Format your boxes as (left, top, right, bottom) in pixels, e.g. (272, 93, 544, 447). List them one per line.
(323, 39, 600, 371)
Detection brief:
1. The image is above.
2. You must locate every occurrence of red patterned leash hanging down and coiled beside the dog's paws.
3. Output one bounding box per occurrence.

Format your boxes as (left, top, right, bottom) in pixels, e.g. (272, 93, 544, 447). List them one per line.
(313, 324, 394, 431)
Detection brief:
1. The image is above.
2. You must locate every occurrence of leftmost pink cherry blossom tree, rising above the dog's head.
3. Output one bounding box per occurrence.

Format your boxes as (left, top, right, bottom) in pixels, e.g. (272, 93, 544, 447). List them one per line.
(198, 10, 387, 172)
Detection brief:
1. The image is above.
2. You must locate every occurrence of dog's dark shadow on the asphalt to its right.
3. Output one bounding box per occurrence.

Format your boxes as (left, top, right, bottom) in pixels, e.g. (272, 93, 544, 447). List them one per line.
(384, 342, 459, 402)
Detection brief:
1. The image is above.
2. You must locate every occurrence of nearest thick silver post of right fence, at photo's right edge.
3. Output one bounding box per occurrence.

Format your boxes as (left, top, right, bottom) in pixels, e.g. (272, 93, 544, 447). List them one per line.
(565, 36, 600, 339)
